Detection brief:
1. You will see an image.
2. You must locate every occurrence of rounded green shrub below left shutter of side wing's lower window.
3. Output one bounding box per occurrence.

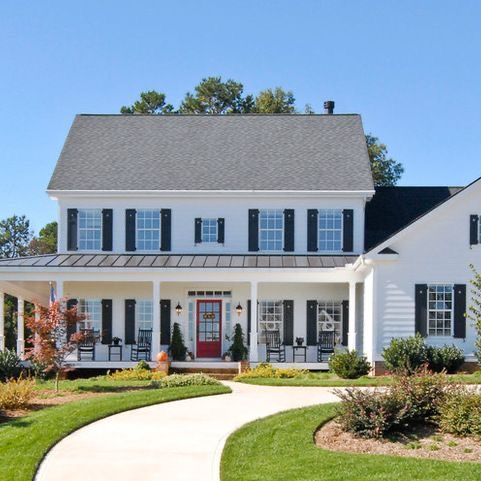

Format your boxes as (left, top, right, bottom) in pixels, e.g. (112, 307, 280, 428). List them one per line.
(382, 334, 429, 374)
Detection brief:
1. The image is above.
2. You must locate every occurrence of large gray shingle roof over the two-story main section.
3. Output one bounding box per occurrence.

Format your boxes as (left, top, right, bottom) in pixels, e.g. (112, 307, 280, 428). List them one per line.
(48, 115, 373, 191)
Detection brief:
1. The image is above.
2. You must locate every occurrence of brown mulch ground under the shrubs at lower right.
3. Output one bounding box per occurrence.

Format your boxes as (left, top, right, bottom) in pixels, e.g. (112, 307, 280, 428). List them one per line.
(315, 420, 481, 462)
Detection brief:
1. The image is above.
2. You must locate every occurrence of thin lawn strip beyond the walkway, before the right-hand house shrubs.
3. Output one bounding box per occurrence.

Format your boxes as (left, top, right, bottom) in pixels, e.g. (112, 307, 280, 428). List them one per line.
(234, 372, 481, 387)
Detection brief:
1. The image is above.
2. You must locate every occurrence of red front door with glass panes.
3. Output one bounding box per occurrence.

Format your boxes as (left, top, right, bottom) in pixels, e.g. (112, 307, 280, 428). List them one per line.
(197, 300, 222, 357)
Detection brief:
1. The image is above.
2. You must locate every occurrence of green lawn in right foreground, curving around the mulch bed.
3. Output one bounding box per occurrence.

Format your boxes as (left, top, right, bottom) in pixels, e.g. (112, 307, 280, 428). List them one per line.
(221, 404, 481, 481)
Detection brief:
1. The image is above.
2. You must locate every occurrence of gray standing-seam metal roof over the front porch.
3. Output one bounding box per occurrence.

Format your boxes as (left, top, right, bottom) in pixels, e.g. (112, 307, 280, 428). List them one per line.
(0, 254, 358, 270)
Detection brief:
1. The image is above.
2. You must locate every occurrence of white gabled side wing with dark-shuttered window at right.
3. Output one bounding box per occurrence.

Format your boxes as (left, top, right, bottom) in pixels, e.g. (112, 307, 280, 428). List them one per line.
(363, 179, 481, 368)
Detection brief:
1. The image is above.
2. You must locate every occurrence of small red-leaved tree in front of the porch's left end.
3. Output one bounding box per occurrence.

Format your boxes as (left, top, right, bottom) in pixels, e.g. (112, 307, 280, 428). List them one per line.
(25, 301, 85, 392)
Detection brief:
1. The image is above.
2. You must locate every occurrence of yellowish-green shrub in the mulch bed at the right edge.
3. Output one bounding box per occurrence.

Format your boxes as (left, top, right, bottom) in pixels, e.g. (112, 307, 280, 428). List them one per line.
(438, 388, 481, 437)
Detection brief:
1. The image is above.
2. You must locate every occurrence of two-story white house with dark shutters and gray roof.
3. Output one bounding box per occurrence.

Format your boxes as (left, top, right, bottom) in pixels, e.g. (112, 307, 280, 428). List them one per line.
(0, 110, 481, 369)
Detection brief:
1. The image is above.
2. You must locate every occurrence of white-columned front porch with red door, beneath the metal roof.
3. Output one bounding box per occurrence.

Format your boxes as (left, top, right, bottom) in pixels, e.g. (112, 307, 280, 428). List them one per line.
(0, 256, 363, 370)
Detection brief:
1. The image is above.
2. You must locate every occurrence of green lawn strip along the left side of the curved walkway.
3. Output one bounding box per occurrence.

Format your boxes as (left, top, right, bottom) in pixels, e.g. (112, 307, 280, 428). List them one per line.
(0, 380, 230, 481)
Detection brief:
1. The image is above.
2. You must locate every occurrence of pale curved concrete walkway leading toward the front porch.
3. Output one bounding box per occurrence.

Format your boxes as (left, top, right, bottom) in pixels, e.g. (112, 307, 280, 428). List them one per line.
(36, 382, 336, 481)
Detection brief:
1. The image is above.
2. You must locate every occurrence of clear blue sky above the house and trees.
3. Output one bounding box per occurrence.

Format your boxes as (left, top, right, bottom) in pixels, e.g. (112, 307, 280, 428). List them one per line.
(0, 0, 481, 231)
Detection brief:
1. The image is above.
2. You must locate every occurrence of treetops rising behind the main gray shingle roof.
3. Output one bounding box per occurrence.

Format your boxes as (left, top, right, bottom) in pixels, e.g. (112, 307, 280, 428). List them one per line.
(120, 76, 404, 186)
